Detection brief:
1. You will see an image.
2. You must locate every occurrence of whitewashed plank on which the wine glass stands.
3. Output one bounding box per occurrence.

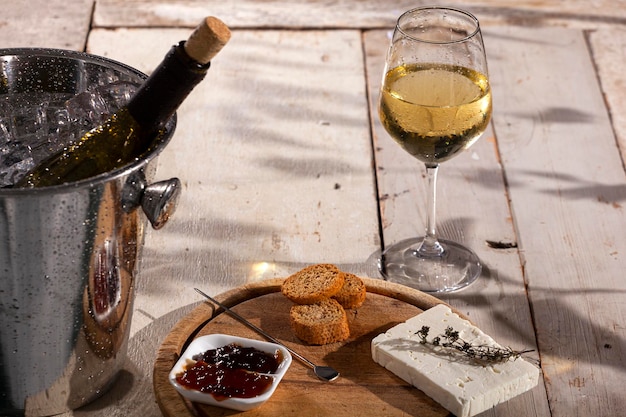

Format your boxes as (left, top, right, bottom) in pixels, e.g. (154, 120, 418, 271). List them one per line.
(365, 31, 549, 416)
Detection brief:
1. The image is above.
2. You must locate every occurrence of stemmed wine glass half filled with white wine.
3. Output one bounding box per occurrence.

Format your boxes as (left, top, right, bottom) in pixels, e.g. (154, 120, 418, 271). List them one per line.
(379, 7, 491, 293)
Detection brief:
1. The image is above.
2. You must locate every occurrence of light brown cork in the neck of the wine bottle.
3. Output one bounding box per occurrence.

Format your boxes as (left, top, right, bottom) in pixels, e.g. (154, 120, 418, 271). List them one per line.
(185, 16, 230, 65)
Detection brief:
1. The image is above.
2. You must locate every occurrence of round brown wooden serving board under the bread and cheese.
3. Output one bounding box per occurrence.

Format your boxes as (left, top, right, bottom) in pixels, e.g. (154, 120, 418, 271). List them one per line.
(153, 278, 458, 417)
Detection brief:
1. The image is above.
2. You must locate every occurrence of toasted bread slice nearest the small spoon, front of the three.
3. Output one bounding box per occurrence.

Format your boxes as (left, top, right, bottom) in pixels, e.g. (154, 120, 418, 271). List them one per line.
(289, 298, 350, 345)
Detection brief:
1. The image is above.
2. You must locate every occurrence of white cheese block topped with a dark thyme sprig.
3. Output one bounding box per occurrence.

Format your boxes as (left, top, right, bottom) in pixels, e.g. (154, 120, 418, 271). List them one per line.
(372, 304, 539, 417)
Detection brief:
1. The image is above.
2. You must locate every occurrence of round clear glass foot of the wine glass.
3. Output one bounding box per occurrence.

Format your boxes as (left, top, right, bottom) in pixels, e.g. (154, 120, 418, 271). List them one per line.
(378, 237, 482, 293)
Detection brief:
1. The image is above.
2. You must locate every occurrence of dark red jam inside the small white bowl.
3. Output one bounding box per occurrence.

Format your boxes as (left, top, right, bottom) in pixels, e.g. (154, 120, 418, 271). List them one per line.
(176, 344, 281, 400)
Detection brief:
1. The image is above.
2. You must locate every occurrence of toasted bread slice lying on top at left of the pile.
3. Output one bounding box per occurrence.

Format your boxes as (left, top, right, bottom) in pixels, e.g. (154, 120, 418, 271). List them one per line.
(281, 264, 345, 304)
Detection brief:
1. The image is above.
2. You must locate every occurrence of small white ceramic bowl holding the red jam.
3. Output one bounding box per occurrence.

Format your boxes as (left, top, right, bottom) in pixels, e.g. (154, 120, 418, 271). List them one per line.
(169, 334, 292, 411)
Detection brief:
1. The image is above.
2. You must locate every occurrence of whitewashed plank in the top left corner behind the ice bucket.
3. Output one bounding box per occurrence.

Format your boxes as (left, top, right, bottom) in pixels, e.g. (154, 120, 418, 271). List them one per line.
(0, 0, 95, 51)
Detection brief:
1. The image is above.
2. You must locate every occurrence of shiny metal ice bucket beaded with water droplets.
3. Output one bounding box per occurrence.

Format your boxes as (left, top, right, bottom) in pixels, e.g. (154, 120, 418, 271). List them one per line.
(0, 49, 179, 416)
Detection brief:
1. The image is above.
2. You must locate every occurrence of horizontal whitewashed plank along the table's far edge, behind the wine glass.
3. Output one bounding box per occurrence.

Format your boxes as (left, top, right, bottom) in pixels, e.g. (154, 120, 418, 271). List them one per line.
(94, 0, 626, 28)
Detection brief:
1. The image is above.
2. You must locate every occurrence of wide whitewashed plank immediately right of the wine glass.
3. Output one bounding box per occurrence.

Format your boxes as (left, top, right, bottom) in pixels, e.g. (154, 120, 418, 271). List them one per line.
(488, 28, 626, 416)
